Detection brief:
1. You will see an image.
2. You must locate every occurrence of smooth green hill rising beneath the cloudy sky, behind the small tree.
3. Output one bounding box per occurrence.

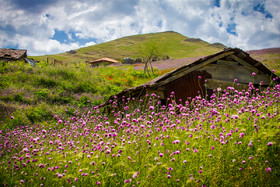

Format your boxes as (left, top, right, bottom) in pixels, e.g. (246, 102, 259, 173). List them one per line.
(31, 31, 225, 63)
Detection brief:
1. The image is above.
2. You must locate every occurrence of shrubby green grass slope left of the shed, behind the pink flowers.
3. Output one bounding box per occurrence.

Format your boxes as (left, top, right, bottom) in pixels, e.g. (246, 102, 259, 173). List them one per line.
(0, 61, 166, 128)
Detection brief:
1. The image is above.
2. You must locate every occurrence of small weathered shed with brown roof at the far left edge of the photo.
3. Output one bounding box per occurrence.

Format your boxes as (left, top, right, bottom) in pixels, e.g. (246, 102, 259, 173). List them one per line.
(0, 48, 27, 61)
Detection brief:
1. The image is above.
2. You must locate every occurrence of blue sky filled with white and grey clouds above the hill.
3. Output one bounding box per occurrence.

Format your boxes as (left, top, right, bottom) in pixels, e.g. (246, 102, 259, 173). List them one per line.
(0, 0, 280, 56)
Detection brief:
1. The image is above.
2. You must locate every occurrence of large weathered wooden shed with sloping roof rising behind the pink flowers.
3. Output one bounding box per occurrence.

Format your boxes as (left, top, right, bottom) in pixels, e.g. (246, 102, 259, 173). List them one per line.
(105, 48, 280, 105)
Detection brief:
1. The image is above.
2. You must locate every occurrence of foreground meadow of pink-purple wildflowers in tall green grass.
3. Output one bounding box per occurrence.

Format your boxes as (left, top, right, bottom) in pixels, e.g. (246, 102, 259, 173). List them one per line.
(0, 79, 280, 186)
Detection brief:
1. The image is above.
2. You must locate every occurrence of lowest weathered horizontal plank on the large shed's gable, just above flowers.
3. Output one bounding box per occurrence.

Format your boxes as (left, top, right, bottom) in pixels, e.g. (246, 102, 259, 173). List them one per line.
(204, 79, 249, 90)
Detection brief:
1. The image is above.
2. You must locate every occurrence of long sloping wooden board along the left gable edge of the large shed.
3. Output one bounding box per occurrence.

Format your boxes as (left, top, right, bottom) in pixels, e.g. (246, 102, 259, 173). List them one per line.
(154, 51, 234, 86)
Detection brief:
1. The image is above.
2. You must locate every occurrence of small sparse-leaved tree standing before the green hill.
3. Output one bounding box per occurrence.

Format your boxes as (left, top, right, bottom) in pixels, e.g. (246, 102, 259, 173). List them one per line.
(139, 40, 164, 75)
